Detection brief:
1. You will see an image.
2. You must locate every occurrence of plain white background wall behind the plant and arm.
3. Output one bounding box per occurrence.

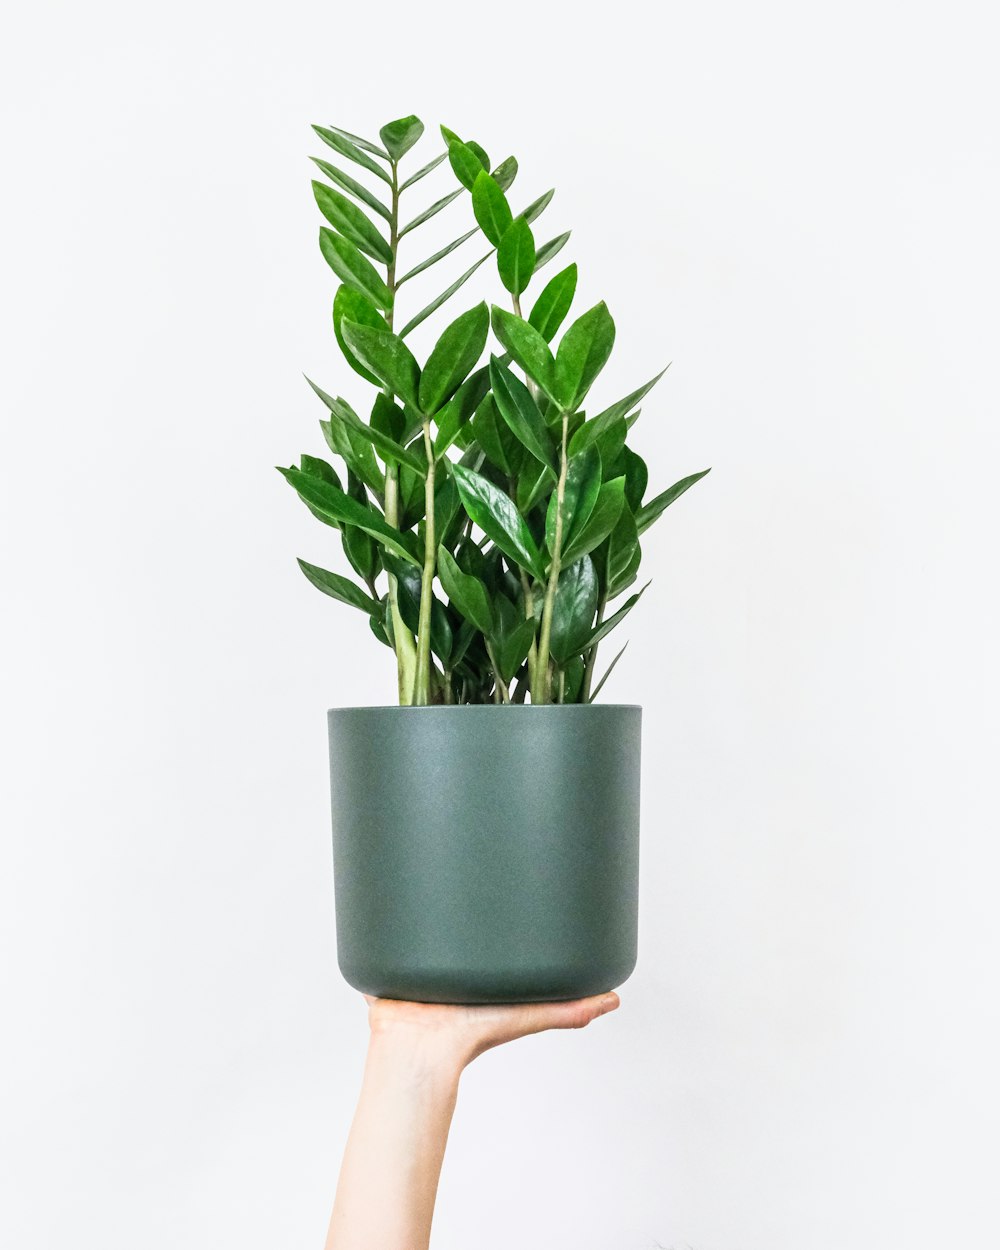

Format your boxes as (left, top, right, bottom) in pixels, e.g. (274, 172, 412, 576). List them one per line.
(0, 0, 1000, 1250)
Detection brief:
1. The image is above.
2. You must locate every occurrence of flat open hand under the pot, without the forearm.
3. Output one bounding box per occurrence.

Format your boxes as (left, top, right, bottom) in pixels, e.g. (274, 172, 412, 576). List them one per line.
(365, 990, 620, 1069)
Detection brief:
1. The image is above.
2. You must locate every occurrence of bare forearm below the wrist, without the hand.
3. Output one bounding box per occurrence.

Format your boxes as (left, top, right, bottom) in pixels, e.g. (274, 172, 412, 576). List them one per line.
(326, 1031, 463, 1250)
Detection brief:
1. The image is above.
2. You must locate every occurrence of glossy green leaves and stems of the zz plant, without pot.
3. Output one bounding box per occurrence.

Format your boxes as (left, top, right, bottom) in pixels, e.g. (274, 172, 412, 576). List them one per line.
(279, 116, 709, 704)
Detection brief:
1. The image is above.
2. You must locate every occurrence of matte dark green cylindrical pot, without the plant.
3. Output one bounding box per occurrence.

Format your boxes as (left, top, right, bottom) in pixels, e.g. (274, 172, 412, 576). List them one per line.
(329, 704, 643, 1003)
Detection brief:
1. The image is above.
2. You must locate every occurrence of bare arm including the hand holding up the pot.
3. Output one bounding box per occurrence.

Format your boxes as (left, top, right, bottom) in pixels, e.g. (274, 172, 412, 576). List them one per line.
(326, 993, 619, 1250)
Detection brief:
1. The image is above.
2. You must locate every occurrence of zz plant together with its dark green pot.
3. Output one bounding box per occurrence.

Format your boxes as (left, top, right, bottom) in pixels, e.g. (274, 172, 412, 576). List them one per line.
(280, 116, 708, 1003)
